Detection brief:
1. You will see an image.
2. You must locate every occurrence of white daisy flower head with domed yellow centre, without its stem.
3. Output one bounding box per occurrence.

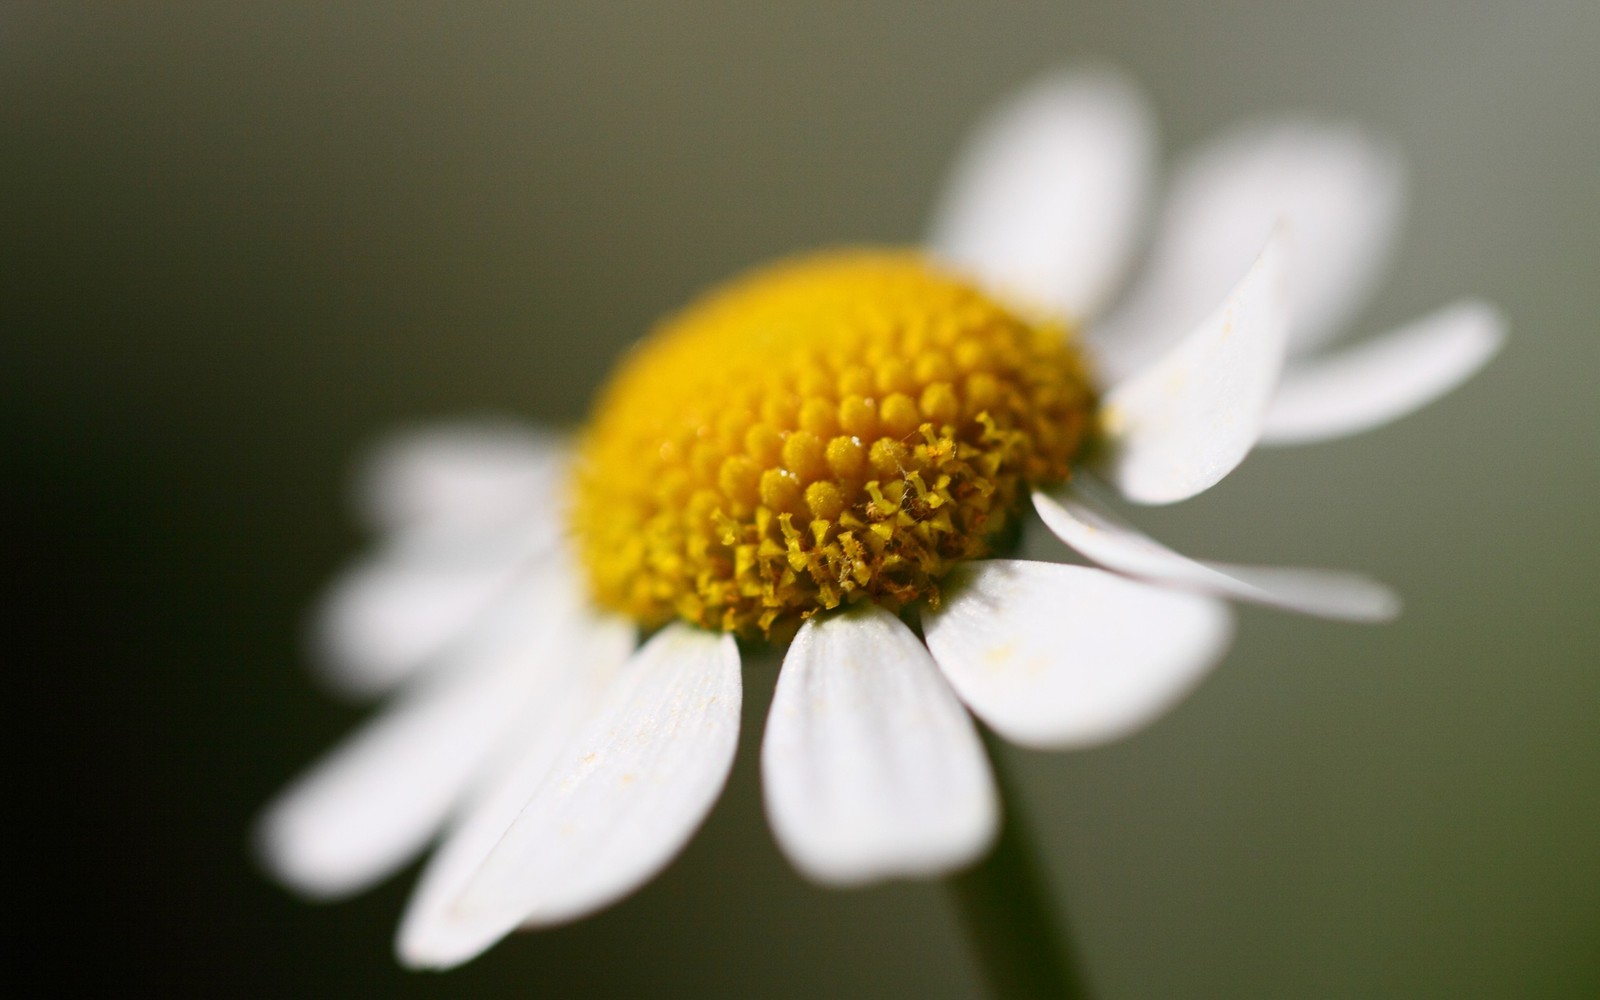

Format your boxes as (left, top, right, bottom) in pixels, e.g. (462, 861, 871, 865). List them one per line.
(261, 69, 1502, 966)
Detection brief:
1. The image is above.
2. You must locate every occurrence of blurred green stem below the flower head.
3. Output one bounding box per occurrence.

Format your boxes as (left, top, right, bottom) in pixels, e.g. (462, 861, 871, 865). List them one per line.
(946, 726, 1090, 1000)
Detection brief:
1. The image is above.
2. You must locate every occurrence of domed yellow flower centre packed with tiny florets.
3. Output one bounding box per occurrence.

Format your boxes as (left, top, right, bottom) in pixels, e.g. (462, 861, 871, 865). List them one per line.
(573, 251, 1094, 635)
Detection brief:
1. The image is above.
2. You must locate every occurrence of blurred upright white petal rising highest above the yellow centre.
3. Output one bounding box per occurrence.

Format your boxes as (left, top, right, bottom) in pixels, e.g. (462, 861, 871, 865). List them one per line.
(931, 69, 1155, 320)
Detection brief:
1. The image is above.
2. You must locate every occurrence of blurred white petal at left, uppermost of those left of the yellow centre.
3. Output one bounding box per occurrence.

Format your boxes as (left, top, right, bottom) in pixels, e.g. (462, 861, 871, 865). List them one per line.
(355, 421, 566, 533)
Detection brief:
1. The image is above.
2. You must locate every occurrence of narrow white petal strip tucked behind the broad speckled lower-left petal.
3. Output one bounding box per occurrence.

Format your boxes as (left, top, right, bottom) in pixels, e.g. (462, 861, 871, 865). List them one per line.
(395, 617, 632, 968)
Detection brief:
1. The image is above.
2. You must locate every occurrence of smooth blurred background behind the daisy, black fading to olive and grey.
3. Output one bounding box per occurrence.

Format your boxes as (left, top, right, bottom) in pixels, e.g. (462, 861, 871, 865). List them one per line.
(12, 0, 1600, 998)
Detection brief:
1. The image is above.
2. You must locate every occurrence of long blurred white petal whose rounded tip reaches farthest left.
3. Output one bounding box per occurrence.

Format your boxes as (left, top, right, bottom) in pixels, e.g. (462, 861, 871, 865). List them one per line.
(261, 569, 626, 896)
